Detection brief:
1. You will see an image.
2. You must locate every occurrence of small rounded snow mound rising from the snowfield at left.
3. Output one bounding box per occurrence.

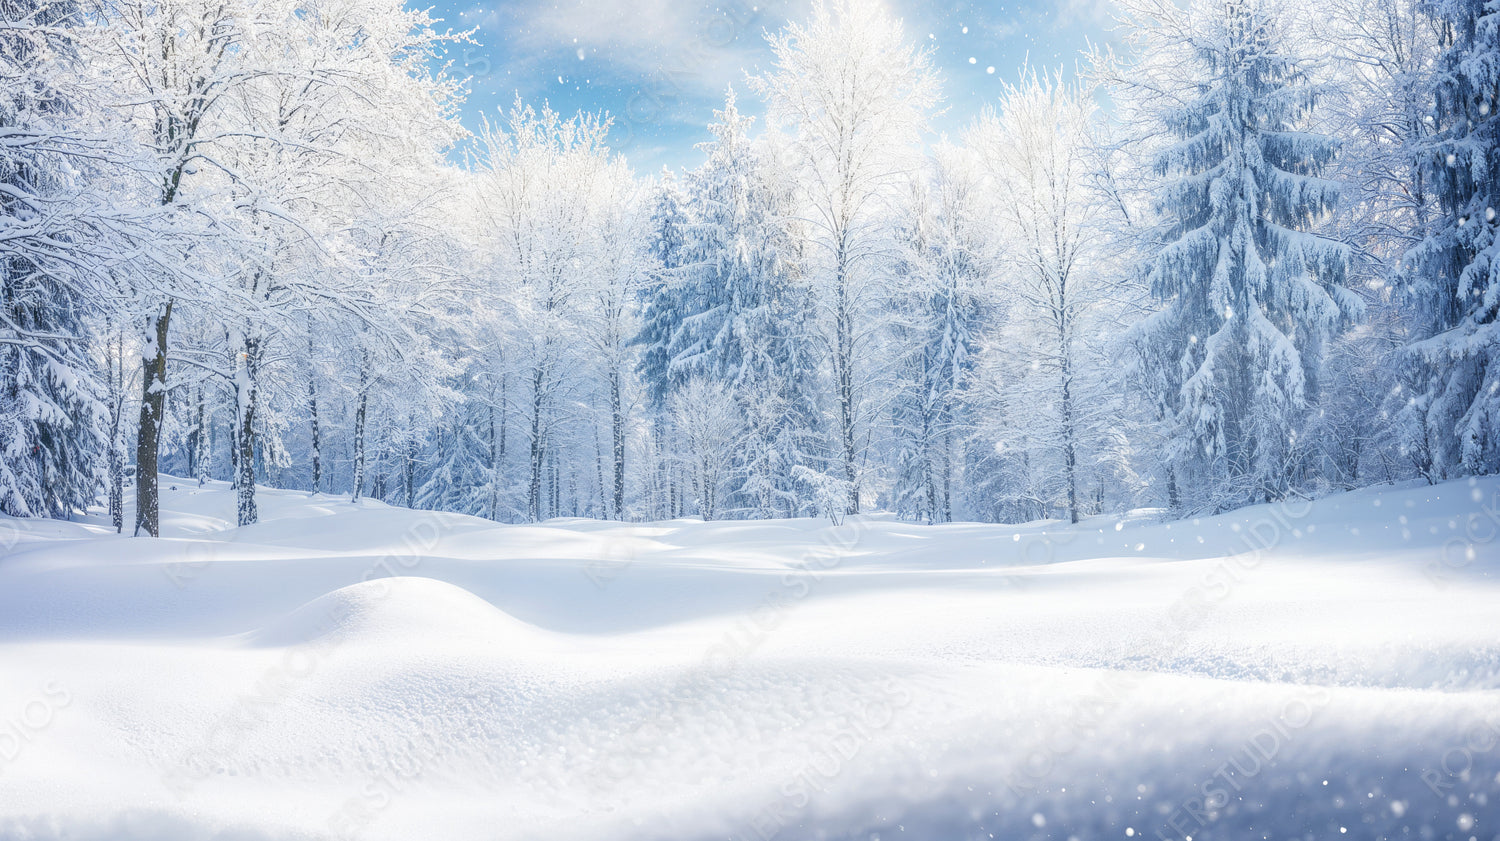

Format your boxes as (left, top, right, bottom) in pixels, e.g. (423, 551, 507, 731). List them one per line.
(249, 577, 539, 648)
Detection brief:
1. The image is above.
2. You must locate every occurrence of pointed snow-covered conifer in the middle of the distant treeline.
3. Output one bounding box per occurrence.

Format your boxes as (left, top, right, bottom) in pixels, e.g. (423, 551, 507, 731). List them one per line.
(638, 90, 815, 516)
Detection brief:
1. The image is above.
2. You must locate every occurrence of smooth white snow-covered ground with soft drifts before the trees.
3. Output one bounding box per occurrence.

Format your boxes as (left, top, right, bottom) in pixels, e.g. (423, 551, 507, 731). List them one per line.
(0, 478, 1500, 841)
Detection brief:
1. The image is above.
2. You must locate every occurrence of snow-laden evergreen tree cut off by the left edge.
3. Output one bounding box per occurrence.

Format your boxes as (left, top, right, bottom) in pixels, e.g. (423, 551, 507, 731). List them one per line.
(0, 0, 111, 517)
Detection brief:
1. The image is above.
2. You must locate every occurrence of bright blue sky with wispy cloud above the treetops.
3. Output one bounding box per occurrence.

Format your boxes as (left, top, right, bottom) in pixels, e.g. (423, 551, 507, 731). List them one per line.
(420, 0, 1110, 174)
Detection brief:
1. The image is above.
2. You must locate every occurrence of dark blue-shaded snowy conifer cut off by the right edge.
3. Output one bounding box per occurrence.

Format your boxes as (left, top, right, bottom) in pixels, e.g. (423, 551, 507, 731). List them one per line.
(1404, 0, 1500, 481)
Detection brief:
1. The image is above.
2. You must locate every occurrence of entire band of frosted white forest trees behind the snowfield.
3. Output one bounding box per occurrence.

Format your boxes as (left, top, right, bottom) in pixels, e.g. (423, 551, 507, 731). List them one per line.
(0, 0, 1500, 534)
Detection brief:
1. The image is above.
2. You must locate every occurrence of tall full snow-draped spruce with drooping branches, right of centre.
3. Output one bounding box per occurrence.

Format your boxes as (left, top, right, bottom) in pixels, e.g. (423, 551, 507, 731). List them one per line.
(1115, 0, 1361, 508)
